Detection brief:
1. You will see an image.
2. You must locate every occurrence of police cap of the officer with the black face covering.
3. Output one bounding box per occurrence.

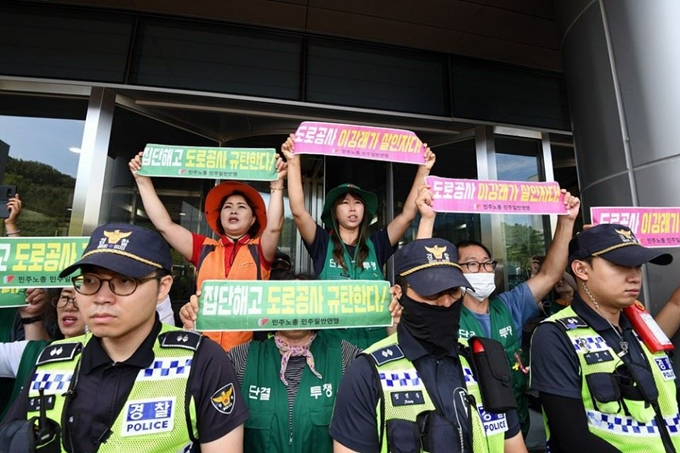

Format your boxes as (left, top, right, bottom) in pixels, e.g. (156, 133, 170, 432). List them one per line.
(394, 238, 472, 297)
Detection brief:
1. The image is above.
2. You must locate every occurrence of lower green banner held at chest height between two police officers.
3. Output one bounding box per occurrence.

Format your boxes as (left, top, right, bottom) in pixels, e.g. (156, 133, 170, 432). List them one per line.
(196, 280, 392, 331)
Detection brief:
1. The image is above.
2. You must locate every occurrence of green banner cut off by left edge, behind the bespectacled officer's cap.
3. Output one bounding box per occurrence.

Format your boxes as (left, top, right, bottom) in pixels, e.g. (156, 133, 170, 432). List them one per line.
(0, 237, 90, 288)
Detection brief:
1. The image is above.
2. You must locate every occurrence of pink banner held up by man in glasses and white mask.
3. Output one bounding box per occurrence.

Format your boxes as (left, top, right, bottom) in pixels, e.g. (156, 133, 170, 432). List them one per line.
(425, 176, 567, 214)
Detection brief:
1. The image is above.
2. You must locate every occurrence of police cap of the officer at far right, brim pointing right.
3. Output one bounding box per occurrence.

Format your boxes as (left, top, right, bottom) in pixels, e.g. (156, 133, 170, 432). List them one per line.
(569, 223, 673, 266)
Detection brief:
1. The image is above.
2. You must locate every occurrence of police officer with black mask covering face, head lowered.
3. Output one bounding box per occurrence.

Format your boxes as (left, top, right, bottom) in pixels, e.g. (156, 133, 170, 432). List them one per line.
(330, 239, 526, 453)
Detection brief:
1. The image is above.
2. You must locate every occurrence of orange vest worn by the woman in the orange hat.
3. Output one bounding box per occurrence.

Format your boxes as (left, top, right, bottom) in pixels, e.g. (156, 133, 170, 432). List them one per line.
(196, 237, 271, 351)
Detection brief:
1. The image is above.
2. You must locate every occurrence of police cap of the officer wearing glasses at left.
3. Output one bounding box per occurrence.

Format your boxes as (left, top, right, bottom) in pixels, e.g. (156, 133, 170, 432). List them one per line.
(59, 223, 172, 278)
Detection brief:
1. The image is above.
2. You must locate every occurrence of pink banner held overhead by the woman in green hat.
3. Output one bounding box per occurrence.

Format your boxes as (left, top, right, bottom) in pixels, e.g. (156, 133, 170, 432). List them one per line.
(295, 121, 425, 165)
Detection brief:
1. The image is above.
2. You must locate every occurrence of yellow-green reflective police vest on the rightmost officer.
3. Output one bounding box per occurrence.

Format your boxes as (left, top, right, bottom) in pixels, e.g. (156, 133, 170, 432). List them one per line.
(544, 306, 680, 453)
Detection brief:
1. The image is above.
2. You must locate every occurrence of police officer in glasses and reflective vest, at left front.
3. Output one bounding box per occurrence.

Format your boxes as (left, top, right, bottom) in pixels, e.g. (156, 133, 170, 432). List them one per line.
(3, 224, 249, 453)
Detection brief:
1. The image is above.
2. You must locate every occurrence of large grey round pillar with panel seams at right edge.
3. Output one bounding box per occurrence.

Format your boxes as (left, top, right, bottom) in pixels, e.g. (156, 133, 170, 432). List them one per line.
(554, 0, 680, 313)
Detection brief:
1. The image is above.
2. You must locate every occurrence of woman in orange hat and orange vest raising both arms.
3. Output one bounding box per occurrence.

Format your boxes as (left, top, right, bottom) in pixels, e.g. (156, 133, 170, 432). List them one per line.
(129, 152, 288, 349)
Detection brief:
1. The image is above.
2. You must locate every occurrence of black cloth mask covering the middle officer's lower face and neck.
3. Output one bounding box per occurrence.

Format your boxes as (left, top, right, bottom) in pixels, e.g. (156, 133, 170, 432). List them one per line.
(399, 293, 463, 354)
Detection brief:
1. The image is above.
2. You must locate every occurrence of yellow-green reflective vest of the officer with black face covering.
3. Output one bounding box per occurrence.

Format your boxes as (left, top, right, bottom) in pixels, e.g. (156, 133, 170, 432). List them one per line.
(364, 333, 507, 453)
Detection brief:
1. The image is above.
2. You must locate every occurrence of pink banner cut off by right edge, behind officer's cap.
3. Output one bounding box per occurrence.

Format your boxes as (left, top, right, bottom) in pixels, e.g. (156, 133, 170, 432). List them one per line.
(590, 206, 680, 247)
